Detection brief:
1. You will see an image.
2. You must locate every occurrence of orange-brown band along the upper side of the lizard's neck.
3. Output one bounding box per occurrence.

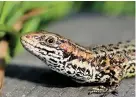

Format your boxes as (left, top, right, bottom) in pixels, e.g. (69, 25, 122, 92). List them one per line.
(59, 40, 95, 60)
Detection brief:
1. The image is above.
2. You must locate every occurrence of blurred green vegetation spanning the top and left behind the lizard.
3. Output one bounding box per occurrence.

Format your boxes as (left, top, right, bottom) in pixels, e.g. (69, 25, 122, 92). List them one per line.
(0, 1, 135, 66)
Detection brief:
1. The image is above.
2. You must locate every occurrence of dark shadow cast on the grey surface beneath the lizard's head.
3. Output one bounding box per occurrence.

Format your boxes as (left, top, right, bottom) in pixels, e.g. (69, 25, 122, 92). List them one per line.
(5, 64, 81, 88)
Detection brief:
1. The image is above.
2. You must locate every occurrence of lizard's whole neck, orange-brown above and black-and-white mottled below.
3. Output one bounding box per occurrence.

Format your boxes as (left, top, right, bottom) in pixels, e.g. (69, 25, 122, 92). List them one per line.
(56, 41, 99, 83)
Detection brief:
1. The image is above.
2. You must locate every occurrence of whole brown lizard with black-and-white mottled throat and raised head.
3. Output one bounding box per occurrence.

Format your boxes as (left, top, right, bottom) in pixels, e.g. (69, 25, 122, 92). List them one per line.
(20, 30, 136, 96)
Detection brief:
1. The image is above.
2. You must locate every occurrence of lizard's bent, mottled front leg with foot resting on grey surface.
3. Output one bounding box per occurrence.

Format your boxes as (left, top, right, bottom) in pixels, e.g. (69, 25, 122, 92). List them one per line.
(89, 65, 123, 97)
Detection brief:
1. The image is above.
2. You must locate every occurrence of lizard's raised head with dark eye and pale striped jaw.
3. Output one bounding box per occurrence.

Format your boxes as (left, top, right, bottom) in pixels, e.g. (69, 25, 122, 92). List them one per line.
(21, 31, 75, 68)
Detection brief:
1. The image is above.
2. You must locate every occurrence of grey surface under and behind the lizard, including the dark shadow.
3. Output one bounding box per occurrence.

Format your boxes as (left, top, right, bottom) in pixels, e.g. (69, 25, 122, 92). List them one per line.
(2, 14, 135, 97)
